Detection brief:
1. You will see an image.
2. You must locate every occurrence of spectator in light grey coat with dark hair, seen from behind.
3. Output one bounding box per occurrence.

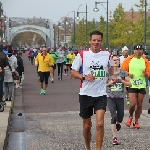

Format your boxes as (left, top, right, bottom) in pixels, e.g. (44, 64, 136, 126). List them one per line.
(4, 45, 17, 101)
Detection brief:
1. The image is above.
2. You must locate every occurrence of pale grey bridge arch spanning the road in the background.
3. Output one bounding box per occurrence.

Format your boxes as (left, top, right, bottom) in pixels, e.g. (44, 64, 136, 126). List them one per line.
(6, 17, 54, 47)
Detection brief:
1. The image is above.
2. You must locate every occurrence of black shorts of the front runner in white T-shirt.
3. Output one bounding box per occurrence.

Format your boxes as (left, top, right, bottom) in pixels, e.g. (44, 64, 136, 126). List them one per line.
(79, 95, 107, 119)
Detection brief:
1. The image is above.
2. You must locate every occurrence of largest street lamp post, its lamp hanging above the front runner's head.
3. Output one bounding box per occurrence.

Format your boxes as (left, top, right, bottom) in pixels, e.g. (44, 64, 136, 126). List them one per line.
(93, 0, 109, 49)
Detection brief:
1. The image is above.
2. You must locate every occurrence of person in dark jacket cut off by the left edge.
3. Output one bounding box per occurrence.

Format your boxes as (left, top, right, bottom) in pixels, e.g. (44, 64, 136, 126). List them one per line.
(0, 44, 8, 102)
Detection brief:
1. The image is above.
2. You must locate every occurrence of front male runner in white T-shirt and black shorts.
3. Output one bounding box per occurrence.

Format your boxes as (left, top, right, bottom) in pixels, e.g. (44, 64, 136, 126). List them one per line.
(71, 31, 111, 150)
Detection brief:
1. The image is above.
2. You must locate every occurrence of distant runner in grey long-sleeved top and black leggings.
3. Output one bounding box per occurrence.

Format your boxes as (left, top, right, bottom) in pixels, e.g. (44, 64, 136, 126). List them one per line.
(56, 46, 65, 80)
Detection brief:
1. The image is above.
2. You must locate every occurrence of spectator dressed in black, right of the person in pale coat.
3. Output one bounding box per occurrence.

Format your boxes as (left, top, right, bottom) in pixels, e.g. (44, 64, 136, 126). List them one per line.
(16, 52, 24, 88)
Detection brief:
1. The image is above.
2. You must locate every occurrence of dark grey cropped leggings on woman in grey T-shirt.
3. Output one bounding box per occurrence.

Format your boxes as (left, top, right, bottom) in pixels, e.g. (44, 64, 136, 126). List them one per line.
(107, 98, 124, 124)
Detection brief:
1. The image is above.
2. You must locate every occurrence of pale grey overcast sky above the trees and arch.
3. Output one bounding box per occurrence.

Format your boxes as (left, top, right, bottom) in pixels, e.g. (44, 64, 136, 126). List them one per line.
(0, 0, 150, 22)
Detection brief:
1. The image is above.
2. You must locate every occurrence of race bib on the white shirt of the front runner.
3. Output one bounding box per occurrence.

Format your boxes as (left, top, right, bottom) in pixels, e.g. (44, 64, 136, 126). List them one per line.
(91, 69, 106, 80)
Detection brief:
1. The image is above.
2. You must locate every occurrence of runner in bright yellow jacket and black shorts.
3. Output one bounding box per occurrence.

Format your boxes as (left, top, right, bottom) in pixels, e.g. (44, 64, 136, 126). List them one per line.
(35, 47, 54, 95)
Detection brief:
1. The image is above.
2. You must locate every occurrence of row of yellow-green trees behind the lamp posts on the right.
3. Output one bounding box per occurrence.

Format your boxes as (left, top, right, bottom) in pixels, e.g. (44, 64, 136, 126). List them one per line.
(76, 0, 150, 48)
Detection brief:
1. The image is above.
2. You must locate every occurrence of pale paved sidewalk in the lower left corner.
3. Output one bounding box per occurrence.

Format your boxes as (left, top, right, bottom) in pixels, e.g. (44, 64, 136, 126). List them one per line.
(0, 102, 11, 150)
